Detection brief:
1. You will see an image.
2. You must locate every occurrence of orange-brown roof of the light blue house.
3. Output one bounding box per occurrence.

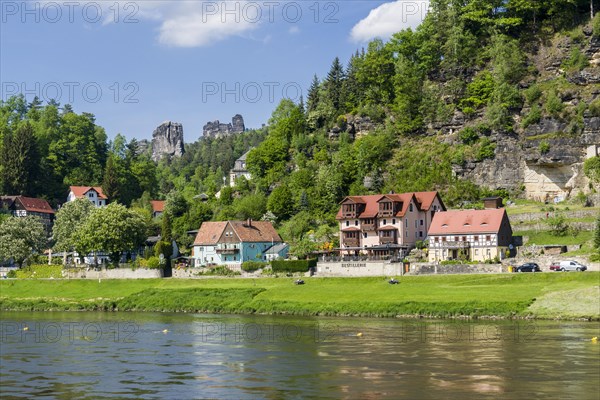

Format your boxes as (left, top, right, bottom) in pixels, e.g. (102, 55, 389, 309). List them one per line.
(194, 221, 282, 245)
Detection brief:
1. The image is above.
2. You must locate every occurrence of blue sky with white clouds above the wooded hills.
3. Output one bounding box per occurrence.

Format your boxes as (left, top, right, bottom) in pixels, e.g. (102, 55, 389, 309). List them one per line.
(0, 0, 428, 142)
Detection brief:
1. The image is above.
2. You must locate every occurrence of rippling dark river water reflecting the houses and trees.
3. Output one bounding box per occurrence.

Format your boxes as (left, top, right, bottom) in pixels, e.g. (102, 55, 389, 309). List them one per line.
(0, 312, 600, 400)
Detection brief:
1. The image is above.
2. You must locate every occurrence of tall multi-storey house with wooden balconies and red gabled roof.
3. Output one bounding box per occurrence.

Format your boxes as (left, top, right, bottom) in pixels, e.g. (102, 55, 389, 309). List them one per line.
(336, 191, 446, 257)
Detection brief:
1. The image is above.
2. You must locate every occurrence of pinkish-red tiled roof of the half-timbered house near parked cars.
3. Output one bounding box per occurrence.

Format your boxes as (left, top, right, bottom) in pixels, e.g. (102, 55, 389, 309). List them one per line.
(428, 208, 510, 235)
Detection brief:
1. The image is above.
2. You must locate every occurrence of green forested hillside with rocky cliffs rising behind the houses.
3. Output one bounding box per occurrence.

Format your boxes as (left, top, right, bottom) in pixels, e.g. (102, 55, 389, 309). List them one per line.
(0, 0, 600, 251)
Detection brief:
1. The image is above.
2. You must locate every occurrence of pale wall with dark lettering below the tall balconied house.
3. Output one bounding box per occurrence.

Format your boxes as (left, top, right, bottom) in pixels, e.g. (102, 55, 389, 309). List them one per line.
(316, 261, 403, 277)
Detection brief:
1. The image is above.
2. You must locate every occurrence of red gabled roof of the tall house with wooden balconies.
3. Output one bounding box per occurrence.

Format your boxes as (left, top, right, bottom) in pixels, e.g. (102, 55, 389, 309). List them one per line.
(336, 191, 445, 219)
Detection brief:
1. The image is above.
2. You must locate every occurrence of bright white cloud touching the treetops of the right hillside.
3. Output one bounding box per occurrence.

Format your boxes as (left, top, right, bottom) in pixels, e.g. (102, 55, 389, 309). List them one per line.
(350, 0, 429, 42)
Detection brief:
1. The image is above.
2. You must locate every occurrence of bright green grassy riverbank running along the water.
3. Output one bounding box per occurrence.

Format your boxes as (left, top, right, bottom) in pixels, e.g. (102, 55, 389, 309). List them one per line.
(0, 272, 600, 320)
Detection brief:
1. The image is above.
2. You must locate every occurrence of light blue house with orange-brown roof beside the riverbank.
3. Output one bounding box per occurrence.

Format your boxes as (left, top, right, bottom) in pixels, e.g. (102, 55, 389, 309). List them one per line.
(192, 219, 282, 267)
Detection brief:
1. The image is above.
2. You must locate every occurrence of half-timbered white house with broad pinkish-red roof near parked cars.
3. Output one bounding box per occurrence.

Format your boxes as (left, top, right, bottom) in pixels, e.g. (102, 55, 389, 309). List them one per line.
(429, 203, 512, 262)
